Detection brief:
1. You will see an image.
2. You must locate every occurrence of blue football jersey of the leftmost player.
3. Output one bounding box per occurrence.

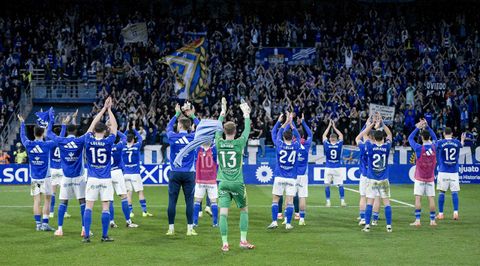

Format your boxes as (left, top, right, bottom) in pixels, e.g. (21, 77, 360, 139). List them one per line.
(20, 123, 55, 179)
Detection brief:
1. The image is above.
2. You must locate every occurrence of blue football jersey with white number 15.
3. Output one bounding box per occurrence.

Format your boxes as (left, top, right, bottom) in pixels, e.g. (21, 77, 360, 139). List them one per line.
(85, 132, 115, 179)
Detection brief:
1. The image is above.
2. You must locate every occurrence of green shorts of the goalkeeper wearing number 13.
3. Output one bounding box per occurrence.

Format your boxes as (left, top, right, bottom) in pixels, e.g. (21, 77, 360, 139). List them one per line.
(218, 181, 247, 209)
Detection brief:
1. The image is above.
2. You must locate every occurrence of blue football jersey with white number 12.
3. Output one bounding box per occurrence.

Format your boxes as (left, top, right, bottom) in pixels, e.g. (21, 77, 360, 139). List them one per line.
(437, 139, 462, 173)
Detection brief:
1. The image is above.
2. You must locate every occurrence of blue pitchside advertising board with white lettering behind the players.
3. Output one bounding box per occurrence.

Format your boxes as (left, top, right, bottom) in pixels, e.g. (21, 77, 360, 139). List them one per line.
(0, 163, 480, 185)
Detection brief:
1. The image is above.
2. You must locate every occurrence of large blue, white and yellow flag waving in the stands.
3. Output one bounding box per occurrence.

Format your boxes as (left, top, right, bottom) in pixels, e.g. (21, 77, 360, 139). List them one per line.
(164, 38, 208, 102)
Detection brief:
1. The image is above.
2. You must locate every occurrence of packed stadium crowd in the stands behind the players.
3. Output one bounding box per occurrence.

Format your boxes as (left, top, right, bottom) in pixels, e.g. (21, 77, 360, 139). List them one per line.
(0, 1, 480, 156)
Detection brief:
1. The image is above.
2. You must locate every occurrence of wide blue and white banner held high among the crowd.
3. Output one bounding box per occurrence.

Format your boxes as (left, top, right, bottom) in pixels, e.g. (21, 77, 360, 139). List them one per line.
(255, 47, 317, 66)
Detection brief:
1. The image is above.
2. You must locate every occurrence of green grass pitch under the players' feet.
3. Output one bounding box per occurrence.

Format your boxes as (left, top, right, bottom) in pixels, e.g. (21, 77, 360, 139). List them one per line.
(0, 185, 480, 265)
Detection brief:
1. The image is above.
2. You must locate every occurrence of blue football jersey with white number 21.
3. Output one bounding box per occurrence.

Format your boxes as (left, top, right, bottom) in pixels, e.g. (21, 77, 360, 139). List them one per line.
(365, 141, 392, 180)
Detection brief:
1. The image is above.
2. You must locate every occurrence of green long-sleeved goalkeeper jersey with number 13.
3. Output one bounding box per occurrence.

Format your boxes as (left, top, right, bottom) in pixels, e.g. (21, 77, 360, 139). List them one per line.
(215, 116, 251, 184)
